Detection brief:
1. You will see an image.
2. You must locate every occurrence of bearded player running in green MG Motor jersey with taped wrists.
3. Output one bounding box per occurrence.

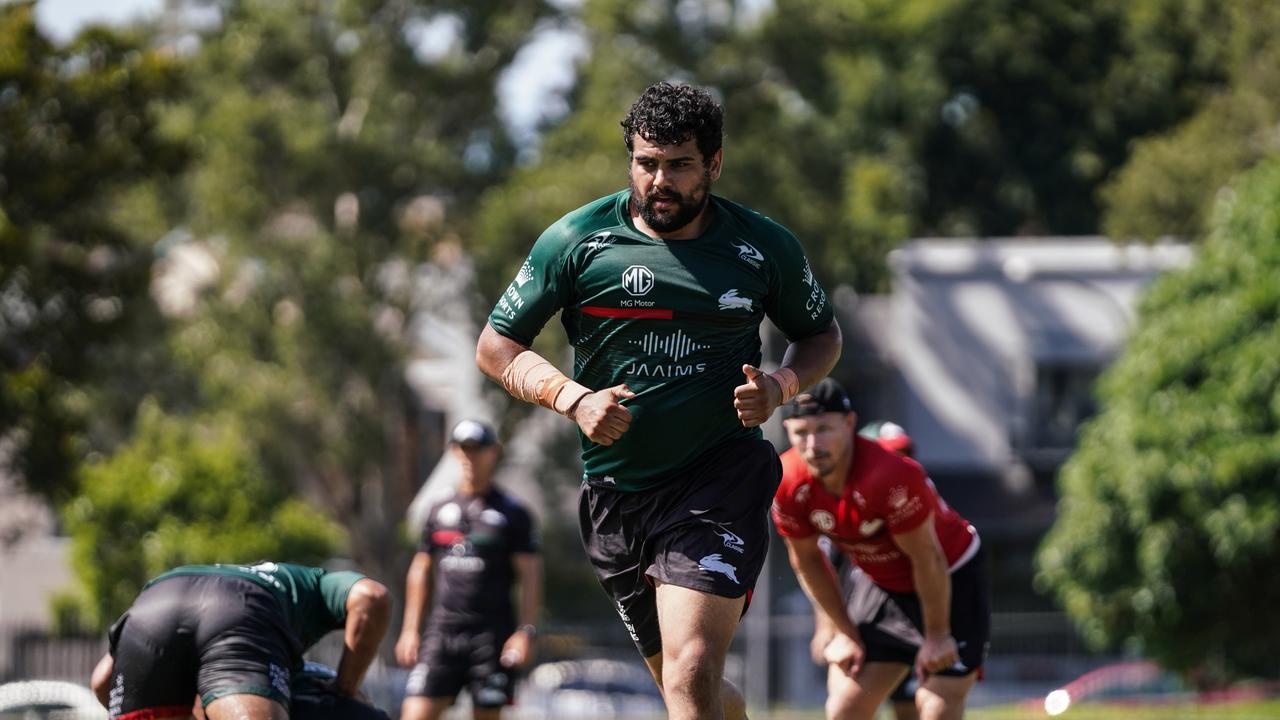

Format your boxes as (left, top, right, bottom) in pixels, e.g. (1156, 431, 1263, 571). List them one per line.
(476, 82, 841, 720)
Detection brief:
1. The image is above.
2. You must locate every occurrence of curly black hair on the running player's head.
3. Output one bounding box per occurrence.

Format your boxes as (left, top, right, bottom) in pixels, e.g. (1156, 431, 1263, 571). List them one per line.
(622, 82, 724, 163)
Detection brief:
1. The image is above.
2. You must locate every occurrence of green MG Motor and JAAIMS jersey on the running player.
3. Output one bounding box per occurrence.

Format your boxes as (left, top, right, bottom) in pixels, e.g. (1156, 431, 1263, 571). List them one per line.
(489, 191, 832, 492)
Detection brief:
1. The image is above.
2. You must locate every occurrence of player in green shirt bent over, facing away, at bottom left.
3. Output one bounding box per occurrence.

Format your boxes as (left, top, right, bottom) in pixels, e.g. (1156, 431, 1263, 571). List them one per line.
(91, 562, 390, 720)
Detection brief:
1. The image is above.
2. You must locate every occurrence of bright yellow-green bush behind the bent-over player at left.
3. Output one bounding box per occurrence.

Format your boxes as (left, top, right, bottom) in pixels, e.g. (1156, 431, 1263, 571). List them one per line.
(63, 401, 342, 629)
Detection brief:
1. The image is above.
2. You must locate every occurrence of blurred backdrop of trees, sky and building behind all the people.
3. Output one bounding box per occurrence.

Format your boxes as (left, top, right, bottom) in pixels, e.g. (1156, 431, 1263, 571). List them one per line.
(0, 0, 1280, 717)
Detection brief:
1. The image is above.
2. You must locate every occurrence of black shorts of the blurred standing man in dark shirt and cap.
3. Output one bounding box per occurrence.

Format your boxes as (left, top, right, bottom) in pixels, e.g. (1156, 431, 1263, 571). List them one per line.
(404, 628, 516, 707)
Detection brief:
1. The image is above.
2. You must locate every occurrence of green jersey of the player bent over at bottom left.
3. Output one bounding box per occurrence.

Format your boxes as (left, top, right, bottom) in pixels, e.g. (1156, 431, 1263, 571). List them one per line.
(146, 562, 365, 652)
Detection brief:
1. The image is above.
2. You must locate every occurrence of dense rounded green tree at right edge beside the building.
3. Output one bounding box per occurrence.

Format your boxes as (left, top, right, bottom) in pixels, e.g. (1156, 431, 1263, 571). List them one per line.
(1037, 161, 1280, 679)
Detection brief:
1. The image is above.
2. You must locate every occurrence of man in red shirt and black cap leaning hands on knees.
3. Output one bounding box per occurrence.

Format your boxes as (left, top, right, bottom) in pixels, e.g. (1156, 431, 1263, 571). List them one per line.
(773, 378, 991, 720)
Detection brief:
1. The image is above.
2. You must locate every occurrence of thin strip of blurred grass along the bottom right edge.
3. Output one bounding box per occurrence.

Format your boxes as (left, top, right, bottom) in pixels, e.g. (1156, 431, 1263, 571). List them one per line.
(753, 700, 1280, 720)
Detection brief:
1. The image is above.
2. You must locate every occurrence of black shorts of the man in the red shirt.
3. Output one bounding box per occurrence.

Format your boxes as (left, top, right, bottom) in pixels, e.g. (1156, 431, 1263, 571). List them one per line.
(841, 548, 991, 671)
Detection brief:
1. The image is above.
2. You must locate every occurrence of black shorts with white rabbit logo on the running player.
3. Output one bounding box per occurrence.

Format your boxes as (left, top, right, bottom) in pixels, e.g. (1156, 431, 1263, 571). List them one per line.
(577, 439, 782, 657)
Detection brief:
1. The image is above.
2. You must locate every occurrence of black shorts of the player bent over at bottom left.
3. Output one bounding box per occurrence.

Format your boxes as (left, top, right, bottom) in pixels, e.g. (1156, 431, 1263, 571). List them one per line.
(108, 575, 301, 720)
